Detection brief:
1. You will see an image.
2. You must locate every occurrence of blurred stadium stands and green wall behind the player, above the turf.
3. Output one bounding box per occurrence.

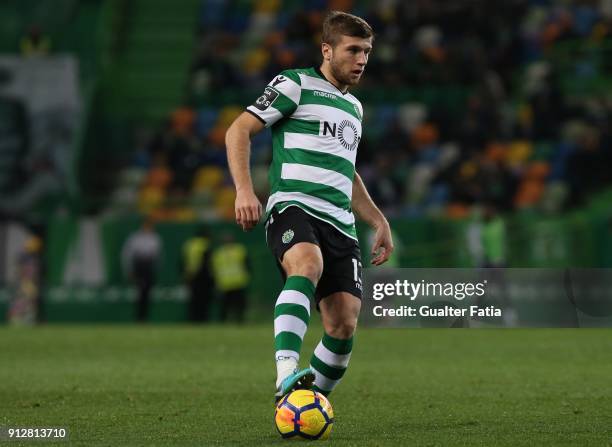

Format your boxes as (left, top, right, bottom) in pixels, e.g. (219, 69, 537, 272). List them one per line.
(0, 0, 612, 321)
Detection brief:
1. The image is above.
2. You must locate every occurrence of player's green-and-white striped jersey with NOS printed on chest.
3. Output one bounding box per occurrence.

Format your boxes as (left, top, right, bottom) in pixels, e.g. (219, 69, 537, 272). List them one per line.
(247, 68, 363, 239)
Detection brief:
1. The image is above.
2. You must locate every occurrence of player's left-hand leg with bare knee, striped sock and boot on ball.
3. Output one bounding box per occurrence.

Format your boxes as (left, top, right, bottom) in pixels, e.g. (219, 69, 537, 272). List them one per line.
(274, 242, 323, 396)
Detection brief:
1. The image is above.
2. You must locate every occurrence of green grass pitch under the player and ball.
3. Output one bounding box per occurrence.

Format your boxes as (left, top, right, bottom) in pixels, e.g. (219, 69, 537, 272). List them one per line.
(0, 326, 612, 447)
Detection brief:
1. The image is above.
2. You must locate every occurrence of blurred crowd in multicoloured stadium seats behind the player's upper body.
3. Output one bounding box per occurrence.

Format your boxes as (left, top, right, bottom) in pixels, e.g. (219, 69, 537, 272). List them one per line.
(120, 0, 612, 219)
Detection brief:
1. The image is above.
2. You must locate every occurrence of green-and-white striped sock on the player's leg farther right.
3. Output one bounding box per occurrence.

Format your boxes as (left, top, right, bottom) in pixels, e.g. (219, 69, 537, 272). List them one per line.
(310, 334, 353, 396)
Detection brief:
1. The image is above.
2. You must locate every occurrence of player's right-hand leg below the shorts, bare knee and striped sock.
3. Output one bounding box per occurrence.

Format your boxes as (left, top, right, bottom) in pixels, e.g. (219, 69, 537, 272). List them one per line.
(310, 292, 361, 395)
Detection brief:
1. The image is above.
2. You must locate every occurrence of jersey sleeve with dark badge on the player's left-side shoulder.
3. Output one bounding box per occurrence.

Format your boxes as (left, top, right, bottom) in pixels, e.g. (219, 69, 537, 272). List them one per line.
(247, 70, 302, 127)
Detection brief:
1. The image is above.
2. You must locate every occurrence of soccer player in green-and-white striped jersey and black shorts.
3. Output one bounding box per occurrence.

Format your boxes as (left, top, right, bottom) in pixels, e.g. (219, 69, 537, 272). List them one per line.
(226, 11, 393, 400)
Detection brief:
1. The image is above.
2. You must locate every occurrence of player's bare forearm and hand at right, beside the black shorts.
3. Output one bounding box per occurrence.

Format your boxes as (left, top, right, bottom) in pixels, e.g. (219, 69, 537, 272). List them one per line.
(351, 172, 393, 265)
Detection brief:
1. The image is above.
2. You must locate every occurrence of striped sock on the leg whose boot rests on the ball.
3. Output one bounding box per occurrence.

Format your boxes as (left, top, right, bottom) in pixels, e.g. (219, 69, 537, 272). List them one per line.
(274, 276, 315, 384)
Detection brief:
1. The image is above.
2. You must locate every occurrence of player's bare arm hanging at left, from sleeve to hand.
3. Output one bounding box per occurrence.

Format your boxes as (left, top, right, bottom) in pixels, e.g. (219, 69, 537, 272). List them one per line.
(225, 112, 264, 231)
